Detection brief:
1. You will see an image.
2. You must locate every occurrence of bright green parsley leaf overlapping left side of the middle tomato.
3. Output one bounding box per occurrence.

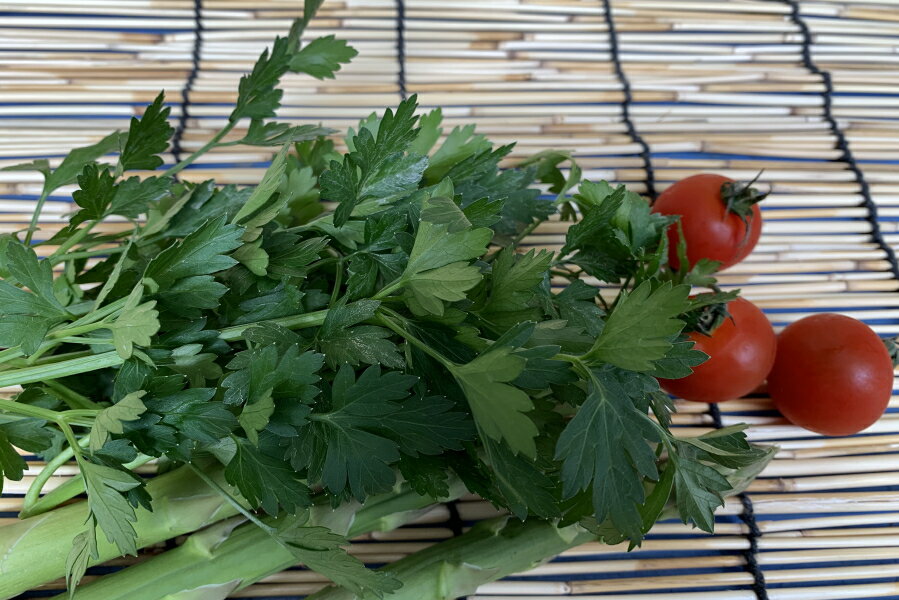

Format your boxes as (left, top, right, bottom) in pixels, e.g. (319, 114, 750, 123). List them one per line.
(584, 281, 690, 371)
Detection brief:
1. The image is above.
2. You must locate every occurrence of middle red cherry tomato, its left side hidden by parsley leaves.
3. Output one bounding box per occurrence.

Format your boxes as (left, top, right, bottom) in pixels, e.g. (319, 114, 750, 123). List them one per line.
(659, 298, 777, 402)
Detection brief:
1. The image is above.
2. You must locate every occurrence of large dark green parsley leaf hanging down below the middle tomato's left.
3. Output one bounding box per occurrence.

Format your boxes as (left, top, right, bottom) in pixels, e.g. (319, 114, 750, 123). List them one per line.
(556, 371, 658, 539)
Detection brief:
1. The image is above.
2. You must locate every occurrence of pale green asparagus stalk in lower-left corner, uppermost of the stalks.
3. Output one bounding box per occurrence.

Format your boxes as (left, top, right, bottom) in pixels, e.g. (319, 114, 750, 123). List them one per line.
(0, 468, 234, 600)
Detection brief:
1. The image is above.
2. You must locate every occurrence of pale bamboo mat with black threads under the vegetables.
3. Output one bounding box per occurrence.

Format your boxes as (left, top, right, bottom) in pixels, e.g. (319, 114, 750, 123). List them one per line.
(0, 0, 899, 600)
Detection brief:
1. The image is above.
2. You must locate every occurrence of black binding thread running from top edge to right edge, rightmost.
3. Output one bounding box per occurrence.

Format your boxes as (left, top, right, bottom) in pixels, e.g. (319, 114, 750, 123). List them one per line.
(782, 0, 899, 279)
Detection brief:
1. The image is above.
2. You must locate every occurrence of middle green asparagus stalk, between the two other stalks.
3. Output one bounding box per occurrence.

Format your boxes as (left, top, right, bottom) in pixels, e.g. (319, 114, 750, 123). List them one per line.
(61, 483, 464, 600)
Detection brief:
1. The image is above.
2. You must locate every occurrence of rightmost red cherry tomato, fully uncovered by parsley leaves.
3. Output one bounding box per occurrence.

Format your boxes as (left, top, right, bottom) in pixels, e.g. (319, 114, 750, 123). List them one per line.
(768, 314, 893, 435)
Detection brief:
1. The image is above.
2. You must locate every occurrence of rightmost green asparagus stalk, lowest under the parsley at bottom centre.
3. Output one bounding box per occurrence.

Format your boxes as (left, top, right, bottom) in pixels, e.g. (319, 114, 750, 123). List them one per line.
(307, 518, 594, 600)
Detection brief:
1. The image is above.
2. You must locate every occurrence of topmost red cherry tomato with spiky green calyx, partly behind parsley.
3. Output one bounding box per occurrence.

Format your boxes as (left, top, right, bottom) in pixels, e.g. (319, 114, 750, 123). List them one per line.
(652, 174, 762, 269)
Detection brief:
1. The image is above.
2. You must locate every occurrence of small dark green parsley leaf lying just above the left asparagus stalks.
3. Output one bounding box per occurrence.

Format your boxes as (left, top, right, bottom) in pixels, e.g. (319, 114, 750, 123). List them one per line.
(225, 438, 311, 515)
